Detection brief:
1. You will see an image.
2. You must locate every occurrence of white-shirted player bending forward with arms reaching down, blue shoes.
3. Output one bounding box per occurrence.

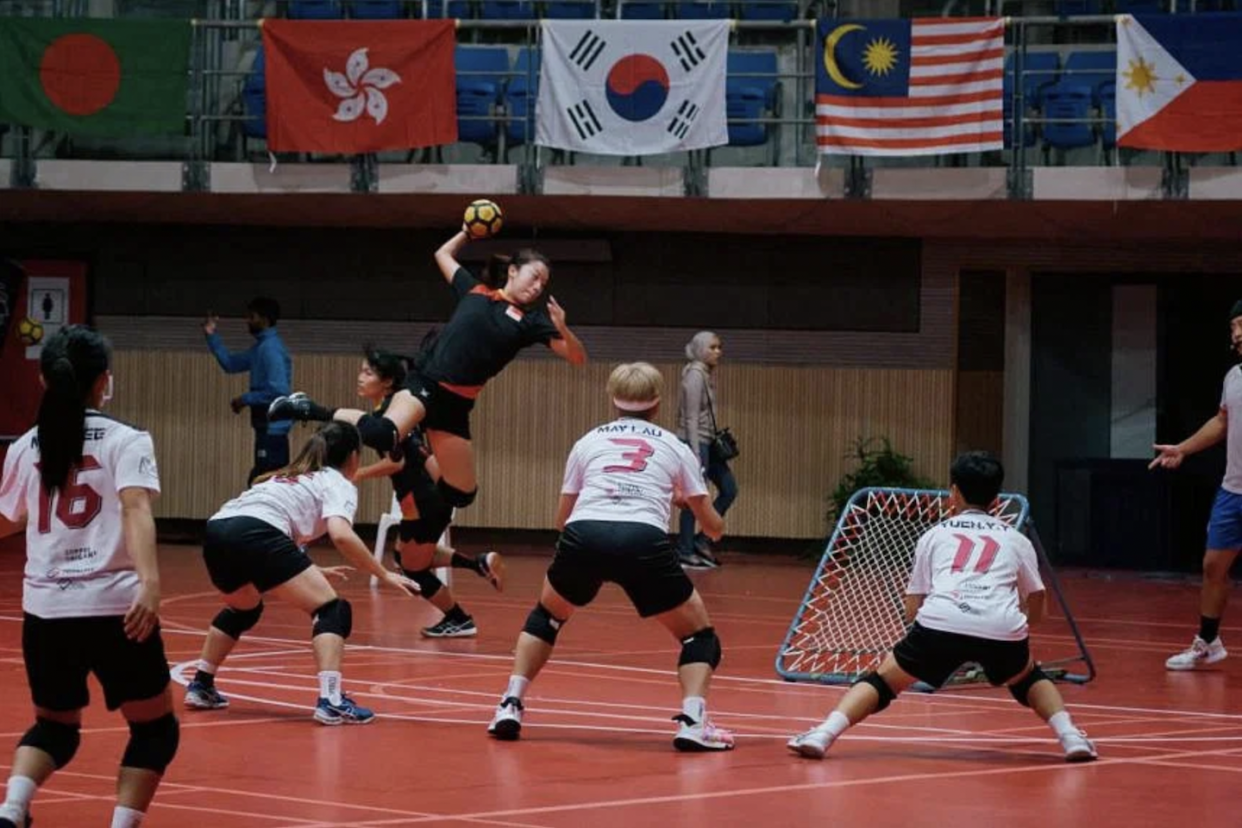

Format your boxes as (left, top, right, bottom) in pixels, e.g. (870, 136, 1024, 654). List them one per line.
(185, 422, 416, 725)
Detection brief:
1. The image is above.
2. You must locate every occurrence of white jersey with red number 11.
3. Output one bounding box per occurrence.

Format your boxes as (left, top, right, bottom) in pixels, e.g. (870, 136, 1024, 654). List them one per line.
(905, 511, 1043, 641)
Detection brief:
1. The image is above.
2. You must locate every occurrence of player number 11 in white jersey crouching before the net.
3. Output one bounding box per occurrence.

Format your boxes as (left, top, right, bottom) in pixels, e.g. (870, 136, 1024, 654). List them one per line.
(789, 452, 1095, 762)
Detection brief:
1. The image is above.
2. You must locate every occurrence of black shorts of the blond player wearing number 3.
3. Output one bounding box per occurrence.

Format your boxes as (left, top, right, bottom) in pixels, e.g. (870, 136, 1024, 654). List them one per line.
(548, 520, 694, 618)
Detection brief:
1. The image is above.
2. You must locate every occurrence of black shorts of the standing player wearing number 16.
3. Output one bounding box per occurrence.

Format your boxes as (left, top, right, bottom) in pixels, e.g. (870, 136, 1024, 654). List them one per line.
(21, 612, 169, 710)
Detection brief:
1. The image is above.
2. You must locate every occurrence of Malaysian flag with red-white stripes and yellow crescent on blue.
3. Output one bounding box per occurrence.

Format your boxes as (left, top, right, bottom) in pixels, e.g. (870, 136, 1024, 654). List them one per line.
(815, 17, 1005, 155)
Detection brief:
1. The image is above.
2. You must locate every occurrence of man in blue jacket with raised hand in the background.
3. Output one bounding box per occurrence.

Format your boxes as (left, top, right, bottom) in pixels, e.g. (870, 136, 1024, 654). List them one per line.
(202, 297, 293, 485)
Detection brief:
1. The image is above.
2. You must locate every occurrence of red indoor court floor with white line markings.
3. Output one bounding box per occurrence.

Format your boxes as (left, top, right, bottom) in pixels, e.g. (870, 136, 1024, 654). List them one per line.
(0, 545, 1242, 828)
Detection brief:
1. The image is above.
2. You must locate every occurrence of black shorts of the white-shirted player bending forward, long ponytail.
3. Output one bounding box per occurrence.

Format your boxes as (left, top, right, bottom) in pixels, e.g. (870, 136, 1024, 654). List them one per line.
(202, 518, 314, 595)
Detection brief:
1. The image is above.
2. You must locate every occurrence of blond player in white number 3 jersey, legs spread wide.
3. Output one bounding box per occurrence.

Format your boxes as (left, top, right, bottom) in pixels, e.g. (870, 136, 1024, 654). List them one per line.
(487, 362, 733, 751)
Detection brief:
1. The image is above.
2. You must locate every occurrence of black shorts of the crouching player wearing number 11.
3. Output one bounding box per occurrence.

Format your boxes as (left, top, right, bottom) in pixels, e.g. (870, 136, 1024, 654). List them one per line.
(893, 623, 1031, 688)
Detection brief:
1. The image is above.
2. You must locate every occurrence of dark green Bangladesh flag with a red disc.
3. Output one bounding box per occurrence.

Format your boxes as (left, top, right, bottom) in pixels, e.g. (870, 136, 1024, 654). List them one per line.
(0, 17, 190, 135)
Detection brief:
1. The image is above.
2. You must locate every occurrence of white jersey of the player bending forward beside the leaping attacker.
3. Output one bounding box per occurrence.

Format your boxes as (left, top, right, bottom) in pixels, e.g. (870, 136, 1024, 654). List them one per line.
(210, 468, 358, 544)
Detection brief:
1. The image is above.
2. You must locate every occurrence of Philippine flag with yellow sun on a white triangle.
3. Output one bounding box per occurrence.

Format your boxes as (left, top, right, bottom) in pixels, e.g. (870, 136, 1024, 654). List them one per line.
(1117, 15, 1242, 153)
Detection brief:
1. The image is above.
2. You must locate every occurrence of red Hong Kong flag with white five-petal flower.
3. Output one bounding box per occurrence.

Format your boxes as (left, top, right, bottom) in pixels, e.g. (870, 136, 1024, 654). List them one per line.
(263, 20, 457, 153)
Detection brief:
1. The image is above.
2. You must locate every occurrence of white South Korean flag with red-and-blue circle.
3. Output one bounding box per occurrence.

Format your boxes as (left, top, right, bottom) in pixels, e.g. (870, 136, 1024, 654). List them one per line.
(535, 20, 729, 155)
